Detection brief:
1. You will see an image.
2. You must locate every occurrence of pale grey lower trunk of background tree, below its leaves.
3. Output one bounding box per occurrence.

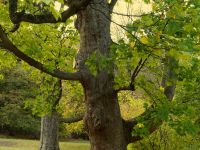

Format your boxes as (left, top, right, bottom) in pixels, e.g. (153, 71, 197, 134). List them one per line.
(39, 112, 59, 150)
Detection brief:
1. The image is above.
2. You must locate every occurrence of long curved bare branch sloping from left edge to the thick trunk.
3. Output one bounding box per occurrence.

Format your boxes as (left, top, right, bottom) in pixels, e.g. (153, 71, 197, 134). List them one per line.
(0, 25, 82, 81)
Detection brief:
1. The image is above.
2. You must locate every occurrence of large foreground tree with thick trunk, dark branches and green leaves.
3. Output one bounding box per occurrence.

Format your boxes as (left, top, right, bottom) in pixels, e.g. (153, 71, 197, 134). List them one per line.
(0, 0, 199, 150)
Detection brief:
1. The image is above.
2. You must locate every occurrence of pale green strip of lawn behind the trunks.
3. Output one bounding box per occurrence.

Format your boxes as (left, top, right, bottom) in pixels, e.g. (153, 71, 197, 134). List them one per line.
(0, 138, 90, 150)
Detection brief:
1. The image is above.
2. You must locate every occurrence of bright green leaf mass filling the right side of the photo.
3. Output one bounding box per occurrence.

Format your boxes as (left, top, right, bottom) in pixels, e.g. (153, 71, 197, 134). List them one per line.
(111, 0, 200, 141)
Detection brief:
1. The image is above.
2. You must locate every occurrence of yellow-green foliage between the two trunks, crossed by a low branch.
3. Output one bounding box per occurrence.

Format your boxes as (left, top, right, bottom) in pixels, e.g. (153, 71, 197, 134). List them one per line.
(58, 81, 87, 138)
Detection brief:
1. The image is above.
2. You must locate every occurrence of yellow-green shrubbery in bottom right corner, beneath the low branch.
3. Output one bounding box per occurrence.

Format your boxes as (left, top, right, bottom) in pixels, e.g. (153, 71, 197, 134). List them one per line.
(128, 124, 200, 150)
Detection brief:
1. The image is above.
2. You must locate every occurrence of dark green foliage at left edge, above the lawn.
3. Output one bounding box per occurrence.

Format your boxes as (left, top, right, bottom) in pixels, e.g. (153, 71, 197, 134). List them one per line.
(0, 63, 40, 137)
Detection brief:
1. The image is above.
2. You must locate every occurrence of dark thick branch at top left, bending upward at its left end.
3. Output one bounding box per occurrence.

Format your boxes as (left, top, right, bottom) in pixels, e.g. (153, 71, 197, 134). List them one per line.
(9, 0, 91, 24)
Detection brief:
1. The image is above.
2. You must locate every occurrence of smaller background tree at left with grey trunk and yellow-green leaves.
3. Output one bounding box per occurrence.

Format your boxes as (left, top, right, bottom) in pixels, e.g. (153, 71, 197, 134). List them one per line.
(1, 12, 83, 149)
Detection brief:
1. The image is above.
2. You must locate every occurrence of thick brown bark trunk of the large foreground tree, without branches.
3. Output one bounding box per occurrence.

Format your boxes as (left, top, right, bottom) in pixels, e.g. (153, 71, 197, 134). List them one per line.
(76, 0, 126, 150)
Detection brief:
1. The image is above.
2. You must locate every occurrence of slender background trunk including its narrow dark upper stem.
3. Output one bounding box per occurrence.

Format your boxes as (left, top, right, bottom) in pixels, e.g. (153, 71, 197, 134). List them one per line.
(39, 80, 62, 150)
